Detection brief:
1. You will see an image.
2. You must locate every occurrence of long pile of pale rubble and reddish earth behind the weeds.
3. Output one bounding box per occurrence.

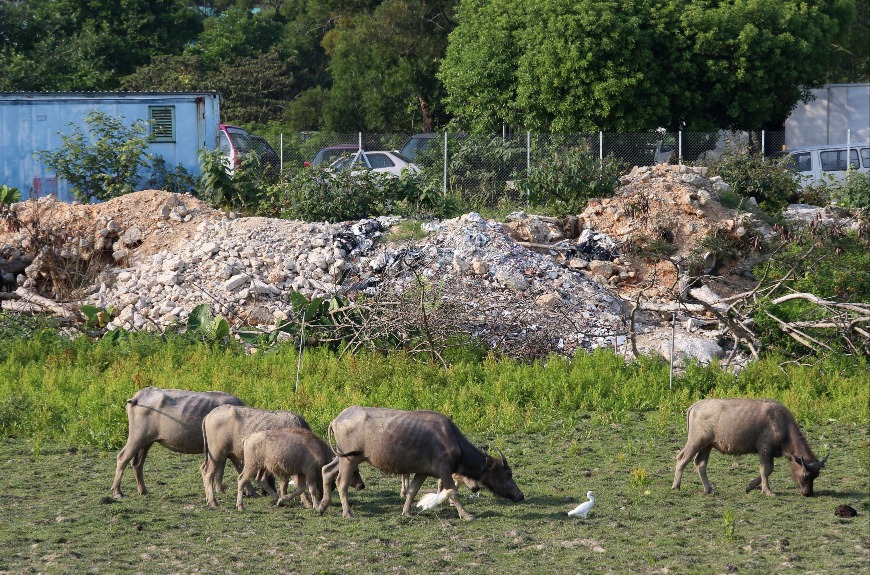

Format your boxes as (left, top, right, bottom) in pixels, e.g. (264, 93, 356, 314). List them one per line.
(0, 165, 804, 361)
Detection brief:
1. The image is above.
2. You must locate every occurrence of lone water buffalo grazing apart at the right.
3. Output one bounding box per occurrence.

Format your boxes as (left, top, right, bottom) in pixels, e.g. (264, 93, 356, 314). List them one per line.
(672, 399, 828, 496)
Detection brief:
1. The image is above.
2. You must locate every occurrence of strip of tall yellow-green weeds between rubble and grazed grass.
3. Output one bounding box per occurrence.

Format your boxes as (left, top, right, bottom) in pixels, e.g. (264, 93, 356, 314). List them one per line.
(0, 324, 867, 449)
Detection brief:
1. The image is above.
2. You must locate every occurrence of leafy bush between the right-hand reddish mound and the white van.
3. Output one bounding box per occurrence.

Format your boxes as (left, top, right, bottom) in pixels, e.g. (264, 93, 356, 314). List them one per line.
(709, 146, 800, 215)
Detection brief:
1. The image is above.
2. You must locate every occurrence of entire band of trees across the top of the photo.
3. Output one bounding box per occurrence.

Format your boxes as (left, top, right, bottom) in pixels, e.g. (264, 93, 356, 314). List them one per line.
(0, 0, 870, 132)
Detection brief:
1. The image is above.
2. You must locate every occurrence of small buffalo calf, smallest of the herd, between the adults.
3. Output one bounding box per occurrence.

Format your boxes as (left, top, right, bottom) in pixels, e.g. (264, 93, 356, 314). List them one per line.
(236, 427, 364, 510)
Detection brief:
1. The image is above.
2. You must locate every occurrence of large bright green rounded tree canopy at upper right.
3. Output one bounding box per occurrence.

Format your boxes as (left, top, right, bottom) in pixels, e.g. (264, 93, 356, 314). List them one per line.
(439, 0, 854, 131)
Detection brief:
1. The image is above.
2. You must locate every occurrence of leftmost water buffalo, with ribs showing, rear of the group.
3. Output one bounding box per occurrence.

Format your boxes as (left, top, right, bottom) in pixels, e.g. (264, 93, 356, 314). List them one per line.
(112, 387, 244, 498)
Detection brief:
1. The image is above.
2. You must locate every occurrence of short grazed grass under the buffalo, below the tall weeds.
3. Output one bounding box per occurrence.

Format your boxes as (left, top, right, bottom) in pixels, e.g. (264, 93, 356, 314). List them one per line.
(0, 414, 870, 575)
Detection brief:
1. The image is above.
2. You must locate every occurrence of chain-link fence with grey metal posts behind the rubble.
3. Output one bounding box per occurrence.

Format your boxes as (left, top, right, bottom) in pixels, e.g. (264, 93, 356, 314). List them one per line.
(260, 130, 785, 207)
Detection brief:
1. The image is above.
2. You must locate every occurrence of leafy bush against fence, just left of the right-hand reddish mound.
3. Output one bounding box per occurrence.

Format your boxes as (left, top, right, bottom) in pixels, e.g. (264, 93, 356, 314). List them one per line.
(521, 147, 625, 215)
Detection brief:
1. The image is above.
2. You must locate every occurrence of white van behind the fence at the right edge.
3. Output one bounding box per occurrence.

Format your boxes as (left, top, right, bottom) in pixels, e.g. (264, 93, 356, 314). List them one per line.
(786, 142, 870, 187)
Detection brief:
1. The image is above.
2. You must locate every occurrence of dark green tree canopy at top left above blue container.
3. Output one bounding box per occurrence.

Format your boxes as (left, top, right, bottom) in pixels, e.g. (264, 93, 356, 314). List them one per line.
(0, 0, 202, 90)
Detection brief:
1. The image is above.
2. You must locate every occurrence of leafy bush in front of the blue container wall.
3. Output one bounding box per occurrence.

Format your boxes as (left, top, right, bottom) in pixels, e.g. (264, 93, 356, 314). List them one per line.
(37, 110, 151, 202)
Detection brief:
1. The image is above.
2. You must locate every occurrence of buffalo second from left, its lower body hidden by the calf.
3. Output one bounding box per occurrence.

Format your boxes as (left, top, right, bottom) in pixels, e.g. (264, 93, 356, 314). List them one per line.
(199, 405, 310, 507)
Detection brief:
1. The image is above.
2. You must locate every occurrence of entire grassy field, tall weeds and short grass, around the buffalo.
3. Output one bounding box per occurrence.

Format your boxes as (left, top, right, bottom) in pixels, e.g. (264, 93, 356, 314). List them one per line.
(0, 332, 870, 575)
